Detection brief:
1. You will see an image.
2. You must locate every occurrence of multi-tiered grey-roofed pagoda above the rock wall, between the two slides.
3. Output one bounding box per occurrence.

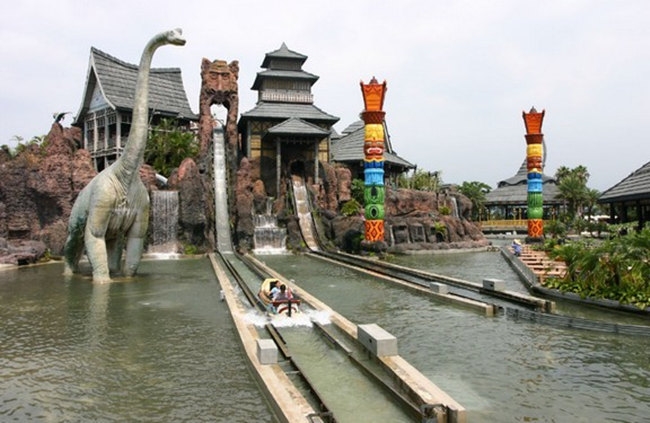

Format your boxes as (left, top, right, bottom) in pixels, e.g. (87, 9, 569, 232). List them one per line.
(239, 43, 339, 198)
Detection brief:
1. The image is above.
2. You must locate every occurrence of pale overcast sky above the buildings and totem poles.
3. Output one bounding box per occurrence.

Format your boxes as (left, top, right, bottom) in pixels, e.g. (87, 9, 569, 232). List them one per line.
(0, 0, 650, 191)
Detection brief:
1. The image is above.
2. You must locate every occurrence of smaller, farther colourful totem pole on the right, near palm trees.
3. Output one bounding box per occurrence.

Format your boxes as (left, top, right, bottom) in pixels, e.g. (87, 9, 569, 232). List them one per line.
(523, 107, 545, 241)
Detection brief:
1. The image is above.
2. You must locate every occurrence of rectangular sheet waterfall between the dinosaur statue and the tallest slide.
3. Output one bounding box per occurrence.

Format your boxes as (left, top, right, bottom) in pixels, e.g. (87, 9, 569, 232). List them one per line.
(149, 191, 178, 254)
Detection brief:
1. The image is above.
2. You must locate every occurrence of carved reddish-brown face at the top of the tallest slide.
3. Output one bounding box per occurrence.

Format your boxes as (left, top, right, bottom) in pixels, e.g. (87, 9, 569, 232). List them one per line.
(201, 59, 239, 104)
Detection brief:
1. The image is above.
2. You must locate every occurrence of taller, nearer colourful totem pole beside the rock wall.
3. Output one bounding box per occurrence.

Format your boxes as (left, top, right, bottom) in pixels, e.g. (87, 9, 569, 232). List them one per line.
(361, 77, 386, 242)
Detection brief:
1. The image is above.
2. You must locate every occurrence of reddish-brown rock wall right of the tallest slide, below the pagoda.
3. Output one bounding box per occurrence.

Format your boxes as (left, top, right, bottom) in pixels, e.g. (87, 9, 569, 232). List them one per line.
(230, 159, 489, 252)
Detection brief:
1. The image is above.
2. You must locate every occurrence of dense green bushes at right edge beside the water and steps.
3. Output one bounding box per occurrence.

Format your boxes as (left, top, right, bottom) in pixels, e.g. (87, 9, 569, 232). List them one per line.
(547, 228, 650, 309)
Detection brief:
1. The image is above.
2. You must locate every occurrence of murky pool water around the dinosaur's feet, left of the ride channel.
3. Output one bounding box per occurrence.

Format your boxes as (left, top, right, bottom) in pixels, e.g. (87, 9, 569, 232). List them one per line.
(0, 259, 275, 422)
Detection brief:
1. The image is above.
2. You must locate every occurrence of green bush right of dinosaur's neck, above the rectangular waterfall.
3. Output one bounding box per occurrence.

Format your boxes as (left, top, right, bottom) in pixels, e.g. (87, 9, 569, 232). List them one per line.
(144, 119, 199, 176)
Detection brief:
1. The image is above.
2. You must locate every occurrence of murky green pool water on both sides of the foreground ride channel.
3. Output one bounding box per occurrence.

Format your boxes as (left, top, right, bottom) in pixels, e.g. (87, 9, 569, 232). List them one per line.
(0, 253, 650, 422)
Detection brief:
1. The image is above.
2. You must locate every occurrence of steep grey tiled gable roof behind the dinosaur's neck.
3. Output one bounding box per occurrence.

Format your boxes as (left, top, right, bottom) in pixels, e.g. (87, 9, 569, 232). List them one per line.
(74, 47, 197, 120)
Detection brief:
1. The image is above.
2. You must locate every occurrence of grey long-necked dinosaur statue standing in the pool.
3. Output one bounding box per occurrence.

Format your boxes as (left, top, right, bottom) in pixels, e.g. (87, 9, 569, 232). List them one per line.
(64, 29, 185, 283)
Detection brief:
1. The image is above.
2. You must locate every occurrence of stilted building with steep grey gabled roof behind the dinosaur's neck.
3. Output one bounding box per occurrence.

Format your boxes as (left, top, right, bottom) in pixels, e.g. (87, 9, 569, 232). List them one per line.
(73, 47, 198, 171)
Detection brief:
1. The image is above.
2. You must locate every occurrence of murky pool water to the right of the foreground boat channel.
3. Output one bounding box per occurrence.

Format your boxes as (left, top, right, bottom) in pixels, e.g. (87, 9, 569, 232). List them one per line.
(264, 252, 650, 422)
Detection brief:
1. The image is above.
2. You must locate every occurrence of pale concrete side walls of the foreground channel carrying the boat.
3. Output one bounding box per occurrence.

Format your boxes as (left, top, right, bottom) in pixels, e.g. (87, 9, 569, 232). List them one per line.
(210, 254, 467, 423)
